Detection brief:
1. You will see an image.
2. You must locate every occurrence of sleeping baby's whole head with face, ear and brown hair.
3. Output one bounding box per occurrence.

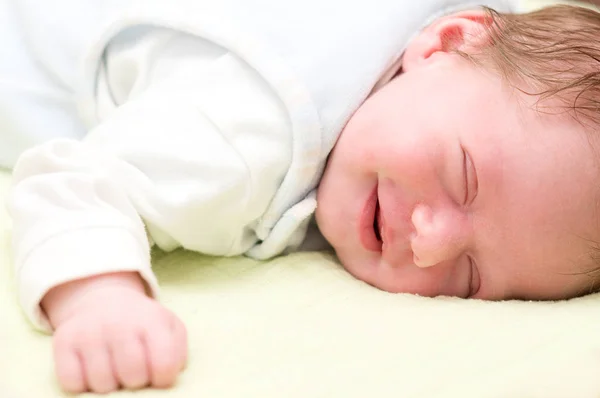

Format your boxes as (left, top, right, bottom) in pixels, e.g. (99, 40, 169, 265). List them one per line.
(317, 6, 600, 299)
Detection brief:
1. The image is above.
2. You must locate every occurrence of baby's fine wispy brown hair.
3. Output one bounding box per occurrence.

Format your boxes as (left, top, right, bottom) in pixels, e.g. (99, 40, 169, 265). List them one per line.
(459, 5, 600, 294)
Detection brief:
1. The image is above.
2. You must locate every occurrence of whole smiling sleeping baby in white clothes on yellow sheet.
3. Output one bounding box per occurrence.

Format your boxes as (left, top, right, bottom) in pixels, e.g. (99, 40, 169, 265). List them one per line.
(0, 0, 600, 393)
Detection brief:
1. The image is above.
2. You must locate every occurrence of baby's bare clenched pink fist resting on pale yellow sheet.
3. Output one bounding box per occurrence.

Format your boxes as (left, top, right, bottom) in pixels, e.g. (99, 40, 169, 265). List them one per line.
(44, 274, 187, 393)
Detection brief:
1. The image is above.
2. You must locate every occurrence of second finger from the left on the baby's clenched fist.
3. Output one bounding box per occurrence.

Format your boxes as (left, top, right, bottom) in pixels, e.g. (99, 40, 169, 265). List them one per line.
(83, 340, 119, 394)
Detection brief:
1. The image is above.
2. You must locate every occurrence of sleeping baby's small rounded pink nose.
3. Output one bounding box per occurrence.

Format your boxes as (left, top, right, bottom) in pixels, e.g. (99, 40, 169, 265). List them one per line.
(411, 205, 472, 267)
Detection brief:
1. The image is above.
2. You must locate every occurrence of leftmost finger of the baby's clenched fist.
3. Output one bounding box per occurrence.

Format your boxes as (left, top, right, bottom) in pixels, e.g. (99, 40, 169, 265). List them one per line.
(54, 336, 87, 394)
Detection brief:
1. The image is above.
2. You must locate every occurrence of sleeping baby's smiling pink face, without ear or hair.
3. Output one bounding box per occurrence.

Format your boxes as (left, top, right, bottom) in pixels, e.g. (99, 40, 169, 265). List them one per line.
(316, 53, 600, 299)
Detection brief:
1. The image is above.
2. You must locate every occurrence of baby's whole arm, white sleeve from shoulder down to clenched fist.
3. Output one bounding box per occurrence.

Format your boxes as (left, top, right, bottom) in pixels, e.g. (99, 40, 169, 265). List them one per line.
(9, 27, 290, 392)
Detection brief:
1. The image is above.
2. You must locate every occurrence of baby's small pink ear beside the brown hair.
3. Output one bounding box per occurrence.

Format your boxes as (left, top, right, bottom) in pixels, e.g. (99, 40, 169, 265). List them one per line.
(402, 10, 492, 72)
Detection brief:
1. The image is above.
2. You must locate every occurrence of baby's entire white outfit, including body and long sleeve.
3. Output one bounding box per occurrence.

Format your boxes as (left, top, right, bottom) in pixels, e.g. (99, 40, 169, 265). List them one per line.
(0, 0, 514, 330)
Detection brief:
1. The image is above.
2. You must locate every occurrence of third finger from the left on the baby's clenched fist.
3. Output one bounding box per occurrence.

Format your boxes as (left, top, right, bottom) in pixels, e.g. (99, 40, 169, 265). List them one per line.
(111, 335, 150, 390)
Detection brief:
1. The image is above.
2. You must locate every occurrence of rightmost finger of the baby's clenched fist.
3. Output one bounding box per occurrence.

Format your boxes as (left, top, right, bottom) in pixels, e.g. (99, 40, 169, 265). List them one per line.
(144, 325, 181, 388)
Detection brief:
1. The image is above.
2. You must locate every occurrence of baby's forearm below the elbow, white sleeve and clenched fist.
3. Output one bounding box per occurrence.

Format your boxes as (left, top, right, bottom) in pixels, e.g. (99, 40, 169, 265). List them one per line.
(10, 131, 187, 393)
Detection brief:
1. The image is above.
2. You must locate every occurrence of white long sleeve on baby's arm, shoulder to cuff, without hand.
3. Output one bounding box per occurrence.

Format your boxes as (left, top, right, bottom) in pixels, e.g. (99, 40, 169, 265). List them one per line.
(9, 29, 291, 330)
